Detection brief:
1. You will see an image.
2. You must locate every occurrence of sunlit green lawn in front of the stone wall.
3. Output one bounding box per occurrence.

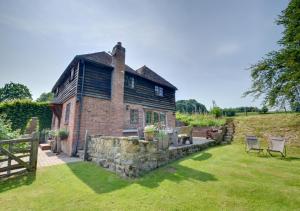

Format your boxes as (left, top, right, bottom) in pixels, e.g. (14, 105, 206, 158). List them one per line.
(0, 116, 300, 210)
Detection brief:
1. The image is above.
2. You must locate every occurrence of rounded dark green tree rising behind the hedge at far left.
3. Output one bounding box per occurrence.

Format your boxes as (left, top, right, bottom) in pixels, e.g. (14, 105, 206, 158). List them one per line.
(0, 82, 32, 102)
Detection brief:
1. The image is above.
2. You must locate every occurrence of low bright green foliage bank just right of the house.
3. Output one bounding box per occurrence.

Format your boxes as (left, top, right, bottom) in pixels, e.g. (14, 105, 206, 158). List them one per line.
(176, 112, 226, 127)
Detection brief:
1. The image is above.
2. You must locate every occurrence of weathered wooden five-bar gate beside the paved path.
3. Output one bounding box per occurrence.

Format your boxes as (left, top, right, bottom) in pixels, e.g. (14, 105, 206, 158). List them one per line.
(0, 134, 39, 179)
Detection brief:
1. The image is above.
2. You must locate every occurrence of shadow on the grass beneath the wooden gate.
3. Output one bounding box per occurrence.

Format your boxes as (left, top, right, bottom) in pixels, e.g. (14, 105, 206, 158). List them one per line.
(0, 173, 36, 193)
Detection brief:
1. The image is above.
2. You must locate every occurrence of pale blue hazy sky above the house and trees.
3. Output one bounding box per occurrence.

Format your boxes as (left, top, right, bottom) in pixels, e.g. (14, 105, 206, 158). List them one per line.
(0, 0, 289, 108)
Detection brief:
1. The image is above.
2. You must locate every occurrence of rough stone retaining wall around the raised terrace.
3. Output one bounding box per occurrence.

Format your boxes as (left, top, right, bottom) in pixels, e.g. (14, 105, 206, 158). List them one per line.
(87, 136, 216, 177)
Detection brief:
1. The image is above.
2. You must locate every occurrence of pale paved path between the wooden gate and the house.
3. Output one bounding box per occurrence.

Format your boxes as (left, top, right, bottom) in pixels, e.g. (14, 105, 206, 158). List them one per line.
(37, 148, 82, 168)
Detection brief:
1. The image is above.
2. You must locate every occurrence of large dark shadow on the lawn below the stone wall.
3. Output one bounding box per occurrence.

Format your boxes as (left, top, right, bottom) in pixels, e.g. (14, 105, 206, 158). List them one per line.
(67, 153, 217, 194)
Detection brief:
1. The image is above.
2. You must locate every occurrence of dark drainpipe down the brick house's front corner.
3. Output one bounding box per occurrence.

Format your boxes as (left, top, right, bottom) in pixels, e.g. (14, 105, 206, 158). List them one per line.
(72, 60, 85, 157)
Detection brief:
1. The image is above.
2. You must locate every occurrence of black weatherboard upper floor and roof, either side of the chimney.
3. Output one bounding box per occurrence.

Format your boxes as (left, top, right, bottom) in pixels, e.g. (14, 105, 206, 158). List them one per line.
(52, 52, 177, 111)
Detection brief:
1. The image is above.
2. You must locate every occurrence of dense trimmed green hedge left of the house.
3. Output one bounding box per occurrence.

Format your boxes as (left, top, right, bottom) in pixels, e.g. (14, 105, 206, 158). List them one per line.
(0, 100, 52, 133)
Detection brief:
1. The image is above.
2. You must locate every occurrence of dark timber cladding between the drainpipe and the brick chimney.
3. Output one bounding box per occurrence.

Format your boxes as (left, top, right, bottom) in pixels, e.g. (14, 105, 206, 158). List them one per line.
(77, 61, 112, 99)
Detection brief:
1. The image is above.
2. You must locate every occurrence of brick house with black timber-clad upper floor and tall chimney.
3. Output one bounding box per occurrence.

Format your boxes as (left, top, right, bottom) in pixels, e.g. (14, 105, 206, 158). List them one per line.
(51, 42, 177, 155)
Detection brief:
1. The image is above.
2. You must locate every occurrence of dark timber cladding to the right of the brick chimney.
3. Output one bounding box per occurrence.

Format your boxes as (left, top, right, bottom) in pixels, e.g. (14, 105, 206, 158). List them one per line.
(124, 72, 175, 111)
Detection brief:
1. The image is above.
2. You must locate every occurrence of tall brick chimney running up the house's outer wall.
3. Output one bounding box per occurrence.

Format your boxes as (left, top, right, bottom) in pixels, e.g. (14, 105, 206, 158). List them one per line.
(111, 42, 125, 136)
